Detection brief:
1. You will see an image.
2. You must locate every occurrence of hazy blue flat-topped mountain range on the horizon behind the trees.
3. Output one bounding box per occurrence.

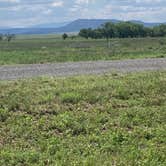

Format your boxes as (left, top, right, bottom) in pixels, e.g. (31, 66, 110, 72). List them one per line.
(0, 19, 165, 35)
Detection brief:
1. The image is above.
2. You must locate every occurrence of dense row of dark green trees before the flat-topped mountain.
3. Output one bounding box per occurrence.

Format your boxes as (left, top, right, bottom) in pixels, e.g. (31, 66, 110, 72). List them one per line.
(79, 22, 166, 39)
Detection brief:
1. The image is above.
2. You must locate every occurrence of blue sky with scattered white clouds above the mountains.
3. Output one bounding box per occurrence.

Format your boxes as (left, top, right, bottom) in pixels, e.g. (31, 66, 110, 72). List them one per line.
(0, 0, 166, 28)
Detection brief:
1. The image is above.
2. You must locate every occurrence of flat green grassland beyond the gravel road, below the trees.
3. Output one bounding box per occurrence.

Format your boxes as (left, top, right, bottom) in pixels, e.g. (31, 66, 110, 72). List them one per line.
(0, 36, 166, 65)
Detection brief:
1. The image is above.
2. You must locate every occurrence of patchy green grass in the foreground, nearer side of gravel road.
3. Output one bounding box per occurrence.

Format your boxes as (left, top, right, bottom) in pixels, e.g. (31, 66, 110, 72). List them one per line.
(0, 72, 166, 166)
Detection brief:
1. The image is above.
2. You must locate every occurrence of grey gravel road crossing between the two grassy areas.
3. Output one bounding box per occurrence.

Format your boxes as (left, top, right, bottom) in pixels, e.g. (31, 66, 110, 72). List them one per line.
(0, 58, 166, 80)
